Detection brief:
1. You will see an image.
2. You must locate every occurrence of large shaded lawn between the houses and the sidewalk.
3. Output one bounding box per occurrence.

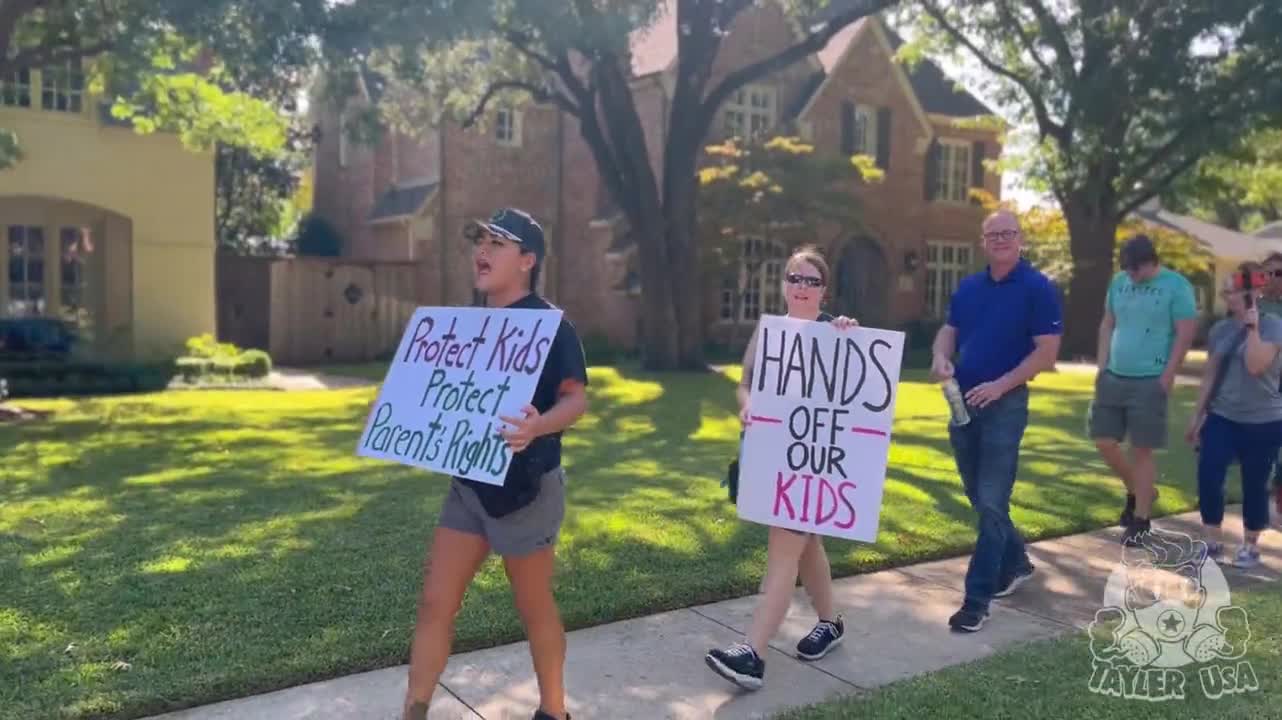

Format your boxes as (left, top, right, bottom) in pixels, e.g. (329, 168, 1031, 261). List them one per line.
(0, 368, 1220, 720)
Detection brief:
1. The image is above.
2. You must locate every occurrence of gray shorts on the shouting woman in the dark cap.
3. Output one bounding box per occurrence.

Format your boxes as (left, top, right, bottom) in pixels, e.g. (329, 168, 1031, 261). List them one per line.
(437, 468, 565, 557)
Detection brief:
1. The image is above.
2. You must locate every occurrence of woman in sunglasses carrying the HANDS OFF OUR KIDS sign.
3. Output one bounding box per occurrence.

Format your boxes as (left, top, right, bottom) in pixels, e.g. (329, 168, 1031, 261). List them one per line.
(705, 247, 859, 691)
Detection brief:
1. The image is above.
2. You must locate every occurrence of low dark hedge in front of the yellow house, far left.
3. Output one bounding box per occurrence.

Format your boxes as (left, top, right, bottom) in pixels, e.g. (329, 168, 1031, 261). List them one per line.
(0, 360, 176, 397)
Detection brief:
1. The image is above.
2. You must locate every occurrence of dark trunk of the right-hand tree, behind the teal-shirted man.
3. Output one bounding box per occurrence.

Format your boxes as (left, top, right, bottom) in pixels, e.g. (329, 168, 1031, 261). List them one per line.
(1061, 193, 1118, 359)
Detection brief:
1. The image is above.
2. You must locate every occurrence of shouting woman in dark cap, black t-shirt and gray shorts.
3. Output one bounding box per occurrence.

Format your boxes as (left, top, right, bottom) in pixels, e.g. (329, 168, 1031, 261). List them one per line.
(405, 209, 587, 720)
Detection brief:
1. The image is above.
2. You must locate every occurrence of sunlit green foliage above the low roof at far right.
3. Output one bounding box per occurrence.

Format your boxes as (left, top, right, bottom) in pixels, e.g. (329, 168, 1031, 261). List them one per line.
(1163, 127, 1282, 232)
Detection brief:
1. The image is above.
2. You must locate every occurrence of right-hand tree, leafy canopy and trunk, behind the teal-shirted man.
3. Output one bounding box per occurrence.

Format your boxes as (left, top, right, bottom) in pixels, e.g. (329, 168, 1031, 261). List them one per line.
(906, 0, 1282, 354)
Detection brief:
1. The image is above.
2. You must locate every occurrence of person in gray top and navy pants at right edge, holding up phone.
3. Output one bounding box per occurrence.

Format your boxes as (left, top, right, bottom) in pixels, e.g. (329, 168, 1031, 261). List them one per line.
(1185, 263, 1282, 568)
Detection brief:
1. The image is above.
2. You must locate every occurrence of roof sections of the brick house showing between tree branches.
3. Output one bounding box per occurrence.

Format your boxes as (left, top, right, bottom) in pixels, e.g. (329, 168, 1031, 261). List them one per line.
(631, 0, 996, 118)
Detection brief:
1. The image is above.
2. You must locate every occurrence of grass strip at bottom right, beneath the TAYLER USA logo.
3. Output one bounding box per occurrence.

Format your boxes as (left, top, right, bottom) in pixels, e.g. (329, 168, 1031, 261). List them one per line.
(778, 585, 1282, 720)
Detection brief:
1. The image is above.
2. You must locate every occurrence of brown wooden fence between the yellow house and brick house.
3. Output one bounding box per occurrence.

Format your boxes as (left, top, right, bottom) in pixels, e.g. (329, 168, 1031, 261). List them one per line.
(218, 255, 424, 365)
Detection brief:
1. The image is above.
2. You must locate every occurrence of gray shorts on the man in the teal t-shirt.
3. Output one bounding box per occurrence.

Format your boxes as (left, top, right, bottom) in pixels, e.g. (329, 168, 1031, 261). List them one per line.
(1087, 372, 1168, 450)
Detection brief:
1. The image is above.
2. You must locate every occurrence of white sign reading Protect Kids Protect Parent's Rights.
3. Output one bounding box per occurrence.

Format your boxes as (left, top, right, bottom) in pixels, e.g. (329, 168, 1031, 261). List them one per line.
(356, 307, 562, 486)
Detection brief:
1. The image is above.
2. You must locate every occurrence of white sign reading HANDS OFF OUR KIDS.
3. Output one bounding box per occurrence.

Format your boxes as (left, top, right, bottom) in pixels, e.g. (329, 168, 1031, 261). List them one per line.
(738, 315, 904, 542)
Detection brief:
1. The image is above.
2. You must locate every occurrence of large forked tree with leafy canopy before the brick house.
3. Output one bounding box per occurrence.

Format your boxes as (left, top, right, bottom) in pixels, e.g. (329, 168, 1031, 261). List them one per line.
(327, 0, 896, 369)
